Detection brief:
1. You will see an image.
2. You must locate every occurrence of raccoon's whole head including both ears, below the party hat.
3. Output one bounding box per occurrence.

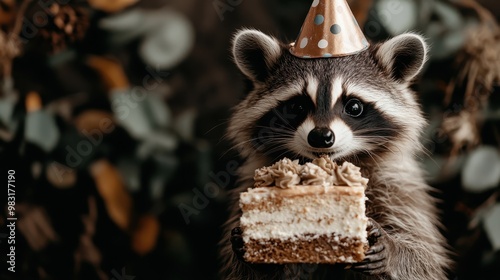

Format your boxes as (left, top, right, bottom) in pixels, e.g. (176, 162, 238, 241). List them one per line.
(229, 30, 427, 164)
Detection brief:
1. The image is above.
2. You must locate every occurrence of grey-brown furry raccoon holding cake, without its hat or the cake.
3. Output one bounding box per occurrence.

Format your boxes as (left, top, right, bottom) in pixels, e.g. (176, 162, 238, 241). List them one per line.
(221, 29, 452, 280)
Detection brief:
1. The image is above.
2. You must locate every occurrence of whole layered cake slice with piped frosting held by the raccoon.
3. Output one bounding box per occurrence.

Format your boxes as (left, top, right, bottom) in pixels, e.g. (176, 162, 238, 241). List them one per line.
(240, 156, 368, 264)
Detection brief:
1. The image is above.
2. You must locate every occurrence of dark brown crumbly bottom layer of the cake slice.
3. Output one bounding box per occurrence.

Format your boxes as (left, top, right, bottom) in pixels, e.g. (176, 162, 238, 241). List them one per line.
(244, 234, 366, 264)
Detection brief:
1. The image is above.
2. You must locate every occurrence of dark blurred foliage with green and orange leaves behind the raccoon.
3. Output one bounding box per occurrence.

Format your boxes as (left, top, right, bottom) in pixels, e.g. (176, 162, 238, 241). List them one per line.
(0, 0, 500, 279)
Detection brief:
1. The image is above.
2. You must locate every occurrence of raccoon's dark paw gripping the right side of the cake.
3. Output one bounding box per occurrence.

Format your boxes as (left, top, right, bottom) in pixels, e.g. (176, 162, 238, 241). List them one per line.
(351, 219, 393, 275)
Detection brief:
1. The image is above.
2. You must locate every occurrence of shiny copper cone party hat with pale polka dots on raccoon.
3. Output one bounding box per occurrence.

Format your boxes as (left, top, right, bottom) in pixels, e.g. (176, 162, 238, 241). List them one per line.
(290, 0, 368, 58)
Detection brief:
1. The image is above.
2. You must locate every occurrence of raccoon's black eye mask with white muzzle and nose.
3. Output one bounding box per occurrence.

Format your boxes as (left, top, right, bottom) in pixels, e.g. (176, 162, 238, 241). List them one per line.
(251, 88, 398, 162)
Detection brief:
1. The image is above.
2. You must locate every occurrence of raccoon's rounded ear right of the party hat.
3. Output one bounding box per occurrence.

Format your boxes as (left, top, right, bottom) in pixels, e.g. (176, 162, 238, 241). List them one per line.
(376, 33, 427, 82)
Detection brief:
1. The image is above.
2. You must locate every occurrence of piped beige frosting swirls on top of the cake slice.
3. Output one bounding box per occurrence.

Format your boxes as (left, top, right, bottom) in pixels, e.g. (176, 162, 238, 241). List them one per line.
(254, 155, 368, 188)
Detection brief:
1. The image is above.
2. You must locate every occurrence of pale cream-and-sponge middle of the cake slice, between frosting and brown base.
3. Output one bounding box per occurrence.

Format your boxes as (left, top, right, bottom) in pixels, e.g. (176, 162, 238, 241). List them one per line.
(240, 186, 367, 242)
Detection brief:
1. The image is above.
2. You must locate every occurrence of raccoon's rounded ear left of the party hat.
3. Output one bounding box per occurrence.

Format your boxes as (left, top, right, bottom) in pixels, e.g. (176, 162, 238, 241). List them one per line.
(233, 29, 281, 82)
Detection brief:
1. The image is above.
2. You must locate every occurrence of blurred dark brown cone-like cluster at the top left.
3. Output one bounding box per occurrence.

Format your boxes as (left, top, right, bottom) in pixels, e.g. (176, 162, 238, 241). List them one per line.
(40, 3, 89, 52)
